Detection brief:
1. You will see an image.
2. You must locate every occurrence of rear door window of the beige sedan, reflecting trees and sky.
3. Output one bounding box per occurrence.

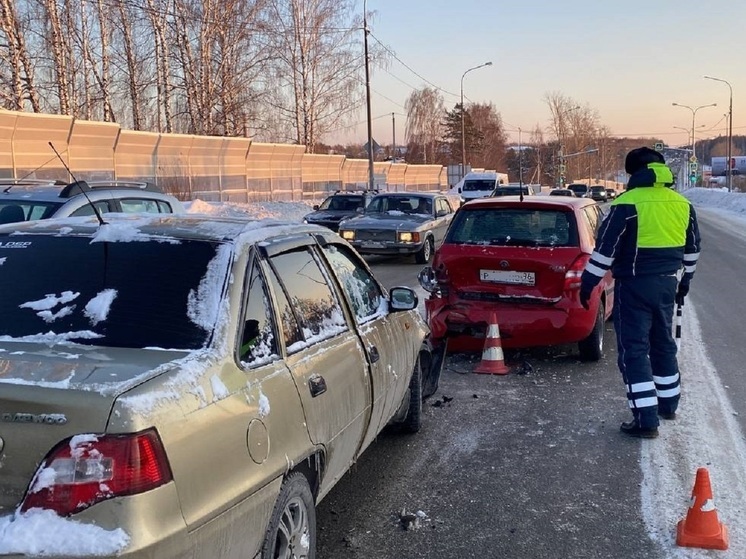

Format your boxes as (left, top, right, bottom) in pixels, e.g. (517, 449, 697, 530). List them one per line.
(270, 247, 348, 352)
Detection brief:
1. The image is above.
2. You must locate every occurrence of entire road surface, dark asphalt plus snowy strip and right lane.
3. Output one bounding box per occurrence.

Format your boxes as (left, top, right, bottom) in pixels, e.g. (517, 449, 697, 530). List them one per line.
(318, 214, 746, 559)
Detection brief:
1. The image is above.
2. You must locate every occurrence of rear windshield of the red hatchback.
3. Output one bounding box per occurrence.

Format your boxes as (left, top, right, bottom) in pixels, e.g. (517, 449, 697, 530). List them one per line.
(445, 208, 580, 247)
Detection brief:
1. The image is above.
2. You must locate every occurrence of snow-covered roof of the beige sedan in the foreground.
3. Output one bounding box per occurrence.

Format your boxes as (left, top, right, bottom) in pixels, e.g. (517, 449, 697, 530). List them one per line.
(0, 214, 330, 242)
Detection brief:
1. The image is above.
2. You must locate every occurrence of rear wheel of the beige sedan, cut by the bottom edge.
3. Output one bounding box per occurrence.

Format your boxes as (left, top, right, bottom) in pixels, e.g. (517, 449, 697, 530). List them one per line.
(261, 472, 316, 559)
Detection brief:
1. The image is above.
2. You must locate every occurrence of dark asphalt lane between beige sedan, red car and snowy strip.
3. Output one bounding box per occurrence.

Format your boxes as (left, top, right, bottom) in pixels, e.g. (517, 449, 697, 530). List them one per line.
(318, 255, 667, 559)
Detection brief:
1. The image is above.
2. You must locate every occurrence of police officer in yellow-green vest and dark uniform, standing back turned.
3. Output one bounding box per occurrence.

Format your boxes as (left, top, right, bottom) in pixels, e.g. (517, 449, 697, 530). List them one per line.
(580, 147, 700, 438)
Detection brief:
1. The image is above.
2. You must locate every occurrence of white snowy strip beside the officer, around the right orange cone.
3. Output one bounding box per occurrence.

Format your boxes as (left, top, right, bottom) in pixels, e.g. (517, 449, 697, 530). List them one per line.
(641, 305, 746, 559)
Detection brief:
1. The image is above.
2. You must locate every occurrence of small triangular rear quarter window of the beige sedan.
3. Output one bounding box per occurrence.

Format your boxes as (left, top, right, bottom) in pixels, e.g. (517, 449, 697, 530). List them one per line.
(238, 264, 278, 367)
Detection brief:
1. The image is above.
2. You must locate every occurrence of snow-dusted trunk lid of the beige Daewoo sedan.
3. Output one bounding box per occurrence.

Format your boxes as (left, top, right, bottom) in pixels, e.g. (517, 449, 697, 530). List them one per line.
(0, 342, 187, 516)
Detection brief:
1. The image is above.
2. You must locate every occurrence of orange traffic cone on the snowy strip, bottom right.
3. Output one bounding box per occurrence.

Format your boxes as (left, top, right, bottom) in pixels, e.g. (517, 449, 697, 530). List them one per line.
(676, 468, 728, 549)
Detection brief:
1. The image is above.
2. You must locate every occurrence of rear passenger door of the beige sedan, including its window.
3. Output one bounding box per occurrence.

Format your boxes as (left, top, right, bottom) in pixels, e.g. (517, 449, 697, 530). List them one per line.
(258, 237, 371, 494)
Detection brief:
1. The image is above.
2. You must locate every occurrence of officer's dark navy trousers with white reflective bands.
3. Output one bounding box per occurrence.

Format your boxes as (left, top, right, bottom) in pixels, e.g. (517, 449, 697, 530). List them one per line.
(614, 275, 681, 429)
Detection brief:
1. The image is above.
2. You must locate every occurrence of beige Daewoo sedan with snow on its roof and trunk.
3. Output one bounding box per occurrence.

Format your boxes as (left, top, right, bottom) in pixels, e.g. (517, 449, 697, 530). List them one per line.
(0, 215, 445, 559)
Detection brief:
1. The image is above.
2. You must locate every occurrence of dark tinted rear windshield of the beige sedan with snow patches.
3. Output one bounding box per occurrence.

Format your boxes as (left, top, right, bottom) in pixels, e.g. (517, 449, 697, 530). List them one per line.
(0, 235, 222, 349)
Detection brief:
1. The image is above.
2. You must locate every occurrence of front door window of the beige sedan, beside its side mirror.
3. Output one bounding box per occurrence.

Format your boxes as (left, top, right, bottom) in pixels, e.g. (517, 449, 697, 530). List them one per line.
(324, 245, 384, 324)
